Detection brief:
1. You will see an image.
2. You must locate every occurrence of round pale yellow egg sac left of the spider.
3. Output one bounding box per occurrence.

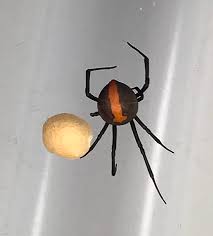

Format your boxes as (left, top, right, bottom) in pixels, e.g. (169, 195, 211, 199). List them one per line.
(43, 113, 92, 159)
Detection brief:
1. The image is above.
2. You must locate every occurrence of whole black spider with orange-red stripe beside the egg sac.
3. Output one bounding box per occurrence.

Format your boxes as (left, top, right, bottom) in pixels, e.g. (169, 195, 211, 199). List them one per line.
(81, 42, 174, 204)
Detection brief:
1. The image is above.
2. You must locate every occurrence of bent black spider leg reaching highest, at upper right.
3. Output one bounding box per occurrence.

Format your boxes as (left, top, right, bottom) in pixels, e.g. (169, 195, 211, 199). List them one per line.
(127, 42, 150, 102)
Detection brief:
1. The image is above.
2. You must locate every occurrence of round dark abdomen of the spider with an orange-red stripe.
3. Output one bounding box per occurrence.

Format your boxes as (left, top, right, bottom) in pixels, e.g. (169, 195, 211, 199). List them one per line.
(98, 80, 138, 125)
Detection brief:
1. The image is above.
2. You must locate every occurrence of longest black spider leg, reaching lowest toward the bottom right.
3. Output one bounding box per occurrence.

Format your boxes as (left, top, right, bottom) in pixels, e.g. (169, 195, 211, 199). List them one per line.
(130, 120, 166, 204)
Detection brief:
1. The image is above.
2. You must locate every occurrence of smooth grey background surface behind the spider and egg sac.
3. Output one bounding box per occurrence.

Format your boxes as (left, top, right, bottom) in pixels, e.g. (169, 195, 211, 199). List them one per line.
(0, 0, 213, 236)
